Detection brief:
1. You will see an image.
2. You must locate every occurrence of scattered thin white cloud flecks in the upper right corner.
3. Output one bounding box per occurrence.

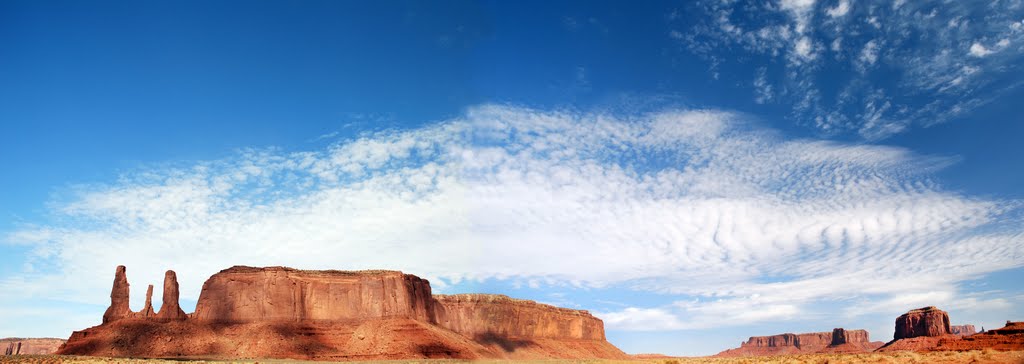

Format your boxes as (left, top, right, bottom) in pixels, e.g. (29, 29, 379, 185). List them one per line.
(667, 0, 1024, 139)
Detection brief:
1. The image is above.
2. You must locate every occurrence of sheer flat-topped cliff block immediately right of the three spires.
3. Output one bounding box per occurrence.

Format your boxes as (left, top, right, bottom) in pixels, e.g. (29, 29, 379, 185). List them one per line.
(193, 266, 433, 323)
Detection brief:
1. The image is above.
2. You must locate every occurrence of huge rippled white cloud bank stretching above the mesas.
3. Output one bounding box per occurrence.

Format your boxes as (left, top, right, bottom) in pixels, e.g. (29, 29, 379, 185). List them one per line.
(0, 105, 1024, 330)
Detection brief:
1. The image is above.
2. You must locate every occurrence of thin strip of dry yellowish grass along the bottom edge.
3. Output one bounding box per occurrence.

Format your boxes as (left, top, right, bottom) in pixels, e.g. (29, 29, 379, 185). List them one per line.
(0, 350, 1024, 364)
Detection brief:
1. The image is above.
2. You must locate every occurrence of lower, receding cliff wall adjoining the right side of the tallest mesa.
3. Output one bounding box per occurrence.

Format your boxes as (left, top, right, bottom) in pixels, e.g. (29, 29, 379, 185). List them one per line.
(434, 294, 604, 340)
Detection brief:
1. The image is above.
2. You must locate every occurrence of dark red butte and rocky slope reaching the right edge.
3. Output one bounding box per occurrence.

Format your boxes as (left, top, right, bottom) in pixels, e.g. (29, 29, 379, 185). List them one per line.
(879, 306, 1024, 352)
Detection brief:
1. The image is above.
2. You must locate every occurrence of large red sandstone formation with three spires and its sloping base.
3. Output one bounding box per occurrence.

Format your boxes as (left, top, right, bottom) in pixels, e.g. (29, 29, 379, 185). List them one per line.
(57, 266, 628, 360)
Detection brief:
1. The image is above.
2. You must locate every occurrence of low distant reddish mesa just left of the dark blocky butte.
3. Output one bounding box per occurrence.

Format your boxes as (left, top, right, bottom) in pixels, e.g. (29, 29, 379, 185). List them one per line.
(715, 328, 883, 357)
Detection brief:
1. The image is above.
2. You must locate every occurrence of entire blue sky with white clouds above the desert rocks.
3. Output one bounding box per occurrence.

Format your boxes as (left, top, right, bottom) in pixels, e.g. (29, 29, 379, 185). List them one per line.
(0, 0, 1024, 355)
